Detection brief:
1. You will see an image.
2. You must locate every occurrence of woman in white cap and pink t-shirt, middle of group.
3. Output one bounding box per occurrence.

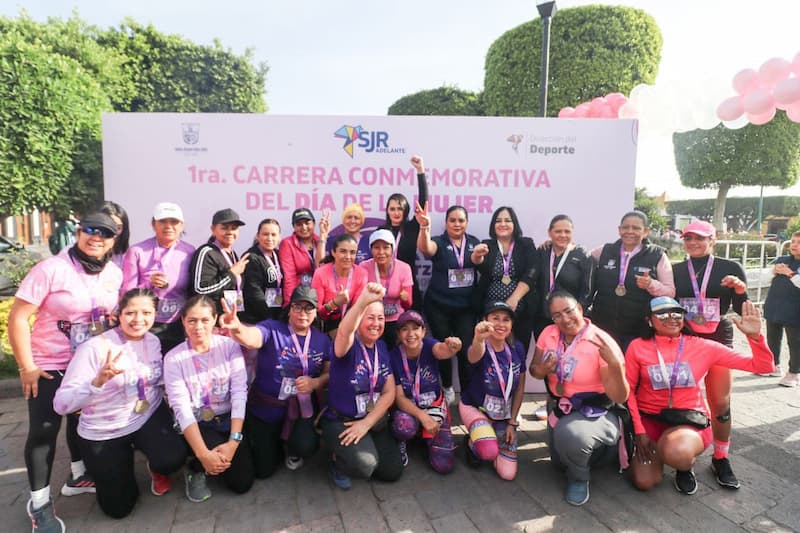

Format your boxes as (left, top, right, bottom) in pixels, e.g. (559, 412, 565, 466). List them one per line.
(360, 229, 414, 348)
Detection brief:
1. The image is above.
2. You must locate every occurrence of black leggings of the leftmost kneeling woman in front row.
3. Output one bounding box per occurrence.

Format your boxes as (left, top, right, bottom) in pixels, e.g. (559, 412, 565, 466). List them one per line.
(78, 401, 188, 518)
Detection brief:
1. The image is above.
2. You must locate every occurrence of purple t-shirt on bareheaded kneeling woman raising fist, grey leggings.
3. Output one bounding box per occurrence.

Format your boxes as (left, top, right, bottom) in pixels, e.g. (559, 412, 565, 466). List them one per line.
(326, 339, 392, 418)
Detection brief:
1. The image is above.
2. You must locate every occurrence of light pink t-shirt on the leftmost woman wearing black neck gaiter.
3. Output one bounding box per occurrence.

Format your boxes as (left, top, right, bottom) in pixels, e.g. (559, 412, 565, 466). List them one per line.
(16, 249, 122, 370)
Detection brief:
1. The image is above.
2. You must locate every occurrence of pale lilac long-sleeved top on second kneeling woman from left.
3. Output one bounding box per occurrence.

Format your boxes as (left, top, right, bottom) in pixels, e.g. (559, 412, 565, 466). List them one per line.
(164, 335, 247, 430)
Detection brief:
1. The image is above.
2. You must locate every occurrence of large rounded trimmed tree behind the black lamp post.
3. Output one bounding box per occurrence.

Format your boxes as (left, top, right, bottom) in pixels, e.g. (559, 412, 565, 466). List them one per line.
(484, 6, 662, 116)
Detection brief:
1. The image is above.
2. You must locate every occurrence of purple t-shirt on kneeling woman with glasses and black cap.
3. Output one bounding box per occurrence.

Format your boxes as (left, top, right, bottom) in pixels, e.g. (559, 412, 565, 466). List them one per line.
(253, 320, 333, 423)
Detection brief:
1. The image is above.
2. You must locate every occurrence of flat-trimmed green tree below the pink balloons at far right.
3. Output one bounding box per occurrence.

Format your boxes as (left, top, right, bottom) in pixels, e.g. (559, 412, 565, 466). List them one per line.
(672, 111, 800, 229)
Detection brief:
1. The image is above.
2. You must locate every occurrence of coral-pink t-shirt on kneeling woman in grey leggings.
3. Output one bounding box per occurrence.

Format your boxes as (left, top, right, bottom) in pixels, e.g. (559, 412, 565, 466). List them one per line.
(536, 318, 623, 398)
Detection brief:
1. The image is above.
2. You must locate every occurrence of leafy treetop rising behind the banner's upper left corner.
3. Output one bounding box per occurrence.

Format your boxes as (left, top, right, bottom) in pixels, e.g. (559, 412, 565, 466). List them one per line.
(99, 19, 268, 113)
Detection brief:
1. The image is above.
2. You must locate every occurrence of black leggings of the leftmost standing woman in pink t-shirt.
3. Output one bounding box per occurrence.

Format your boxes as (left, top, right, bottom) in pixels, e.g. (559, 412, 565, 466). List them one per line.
(25, 370, 81, 491)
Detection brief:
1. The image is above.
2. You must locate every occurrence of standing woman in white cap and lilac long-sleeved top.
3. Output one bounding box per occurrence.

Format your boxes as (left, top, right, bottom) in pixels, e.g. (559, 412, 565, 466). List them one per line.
(120, 202, 194, 354)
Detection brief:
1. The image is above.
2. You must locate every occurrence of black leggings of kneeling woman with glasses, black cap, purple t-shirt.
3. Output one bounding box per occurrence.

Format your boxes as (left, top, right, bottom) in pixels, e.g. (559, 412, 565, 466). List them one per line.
(245, 413, 319, 479)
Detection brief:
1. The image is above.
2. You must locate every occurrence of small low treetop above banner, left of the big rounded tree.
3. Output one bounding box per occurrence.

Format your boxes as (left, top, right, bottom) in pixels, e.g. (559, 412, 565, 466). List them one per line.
(388, 86, 484, 116)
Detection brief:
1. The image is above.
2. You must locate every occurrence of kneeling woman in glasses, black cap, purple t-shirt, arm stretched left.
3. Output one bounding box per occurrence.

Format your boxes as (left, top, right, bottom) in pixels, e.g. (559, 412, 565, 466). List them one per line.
(217, 286, 333, 479)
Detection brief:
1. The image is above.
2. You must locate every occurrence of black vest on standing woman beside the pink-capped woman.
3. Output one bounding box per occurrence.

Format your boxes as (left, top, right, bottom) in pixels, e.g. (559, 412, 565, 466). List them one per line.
(592, 240, 664, 337)
